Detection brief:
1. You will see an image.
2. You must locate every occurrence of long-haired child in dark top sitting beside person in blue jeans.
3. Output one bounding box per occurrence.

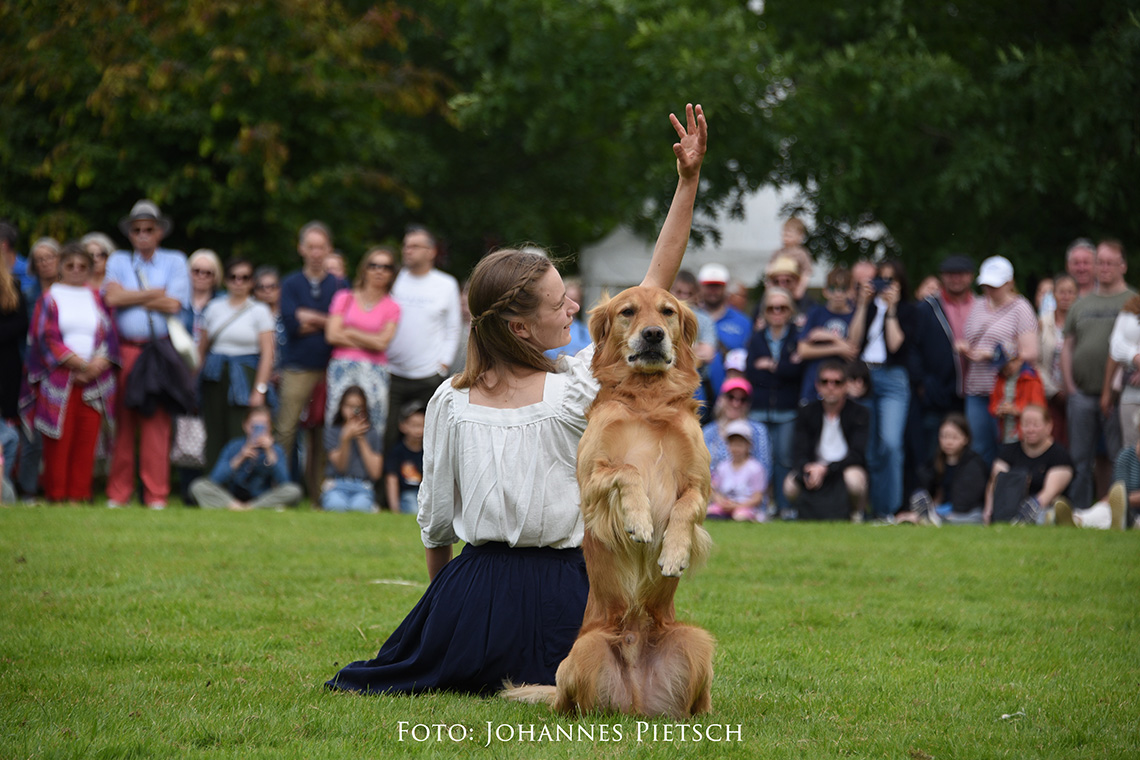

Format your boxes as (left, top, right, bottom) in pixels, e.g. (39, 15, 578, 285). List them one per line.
(896, 411, 988, 526)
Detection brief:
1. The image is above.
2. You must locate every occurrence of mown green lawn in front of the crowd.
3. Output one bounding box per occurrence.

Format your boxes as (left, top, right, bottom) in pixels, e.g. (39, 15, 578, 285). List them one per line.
(0, 507, 1140, 759)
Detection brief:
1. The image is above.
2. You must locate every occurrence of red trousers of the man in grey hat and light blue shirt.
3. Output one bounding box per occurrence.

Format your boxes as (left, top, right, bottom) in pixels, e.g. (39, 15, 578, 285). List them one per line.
(107, 343, 171, 505)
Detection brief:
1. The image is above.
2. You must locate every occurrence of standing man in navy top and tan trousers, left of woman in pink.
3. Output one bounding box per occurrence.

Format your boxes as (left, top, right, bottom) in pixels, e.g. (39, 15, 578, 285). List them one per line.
(277, 221, 348, 498)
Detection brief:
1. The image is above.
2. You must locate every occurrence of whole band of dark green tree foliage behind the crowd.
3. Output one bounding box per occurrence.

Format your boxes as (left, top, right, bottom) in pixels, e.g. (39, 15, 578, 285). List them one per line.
(0, 0, 1140, 282)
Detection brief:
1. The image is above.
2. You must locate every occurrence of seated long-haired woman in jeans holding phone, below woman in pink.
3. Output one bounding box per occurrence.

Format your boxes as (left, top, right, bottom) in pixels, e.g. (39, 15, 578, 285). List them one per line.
(320, 385, 385, 512)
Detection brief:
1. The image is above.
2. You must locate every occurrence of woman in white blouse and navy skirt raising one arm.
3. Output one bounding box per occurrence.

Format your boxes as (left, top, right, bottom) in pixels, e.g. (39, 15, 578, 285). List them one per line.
(327, 106, 706, 694)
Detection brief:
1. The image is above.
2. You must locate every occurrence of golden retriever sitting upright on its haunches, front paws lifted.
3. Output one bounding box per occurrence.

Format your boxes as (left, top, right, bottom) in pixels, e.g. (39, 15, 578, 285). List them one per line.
(506, 287, 715, 719)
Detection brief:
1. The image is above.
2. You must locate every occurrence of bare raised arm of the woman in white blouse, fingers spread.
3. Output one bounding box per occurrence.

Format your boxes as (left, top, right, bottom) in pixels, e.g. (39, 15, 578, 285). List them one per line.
(642, 104, 708, 291)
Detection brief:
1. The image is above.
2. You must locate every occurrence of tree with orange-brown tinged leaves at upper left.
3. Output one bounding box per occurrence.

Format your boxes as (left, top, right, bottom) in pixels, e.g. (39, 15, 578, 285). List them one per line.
(0, 0, 449, 263)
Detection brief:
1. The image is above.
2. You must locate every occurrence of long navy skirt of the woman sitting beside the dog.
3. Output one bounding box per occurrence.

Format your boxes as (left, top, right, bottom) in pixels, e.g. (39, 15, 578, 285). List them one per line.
(326, 544, 589, 694)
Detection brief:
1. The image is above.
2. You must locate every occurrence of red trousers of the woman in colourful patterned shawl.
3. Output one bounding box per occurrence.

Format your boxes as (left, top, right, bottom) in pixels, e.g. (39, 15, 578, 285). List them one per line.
(40, 383, 103, 501)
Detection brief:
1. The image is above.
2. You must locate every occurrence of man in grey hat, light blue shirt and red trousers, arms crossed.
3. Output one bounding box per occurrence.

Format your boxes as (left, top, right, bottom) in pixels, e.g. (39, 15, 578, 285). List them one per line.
(104, 201, 190, 509)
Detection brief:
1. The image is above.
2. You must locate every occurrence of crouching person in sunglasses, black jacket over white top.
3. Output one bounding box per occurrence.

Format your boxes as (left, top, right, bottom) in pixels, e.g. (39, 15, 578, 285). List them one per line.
(783, 359, 870, 522)
